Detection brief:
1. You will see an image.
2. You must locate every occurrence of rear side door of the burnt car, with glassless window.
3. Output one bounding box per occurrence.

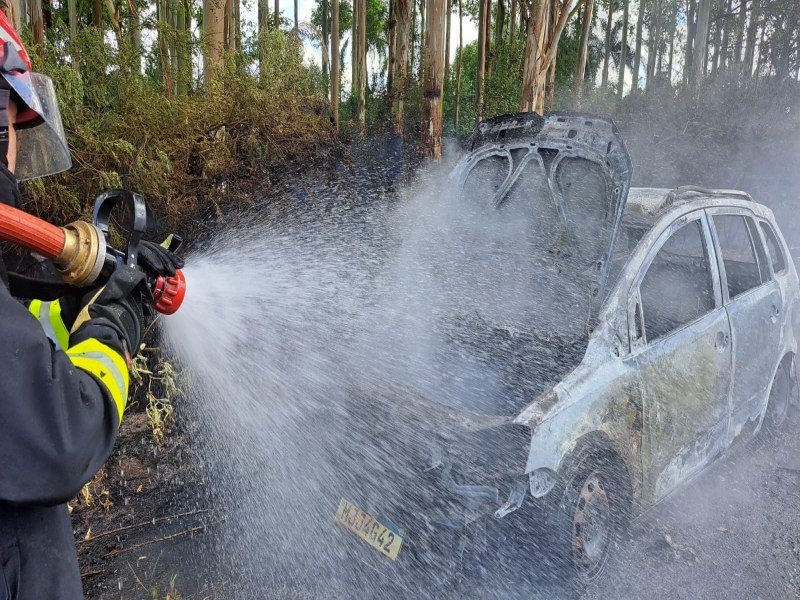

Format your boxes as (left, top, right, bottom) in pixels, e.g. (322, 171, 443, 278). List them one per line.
(708, 208, 783, 437)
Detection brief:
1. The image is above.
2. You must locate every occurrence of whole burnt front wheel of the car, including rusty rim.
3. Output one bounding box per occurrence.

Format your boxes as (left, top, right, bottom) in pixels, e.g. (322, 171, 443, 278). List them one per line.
(551, 450, 630, 589)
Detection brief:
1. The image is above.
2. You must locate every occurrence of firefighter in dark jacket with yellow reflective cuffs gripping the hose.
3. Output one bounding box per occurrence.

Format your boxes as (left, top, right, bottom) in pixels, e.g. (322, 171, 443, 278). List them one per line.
(0, 12, 181, 600)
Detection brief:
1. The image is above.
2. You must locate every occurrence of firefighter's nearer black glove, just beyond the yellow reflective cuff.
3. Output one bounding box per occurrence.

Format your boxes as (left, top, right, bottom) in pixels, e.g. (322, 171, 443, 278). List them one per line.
(70, 266, 152, 358)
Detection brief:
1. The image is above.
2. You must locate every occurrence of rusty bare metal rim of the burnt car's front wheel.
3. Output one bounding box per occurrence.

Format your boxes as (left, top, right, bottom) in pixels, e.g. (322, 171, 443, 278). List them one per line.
(572, 471, 612, 580)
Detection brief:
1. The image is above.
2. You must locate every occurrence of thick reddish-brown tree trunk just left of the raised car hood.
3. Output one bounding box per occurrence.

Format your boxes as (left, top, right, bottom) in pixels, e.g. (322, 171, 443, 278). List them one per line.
(421, 0, 445, 162)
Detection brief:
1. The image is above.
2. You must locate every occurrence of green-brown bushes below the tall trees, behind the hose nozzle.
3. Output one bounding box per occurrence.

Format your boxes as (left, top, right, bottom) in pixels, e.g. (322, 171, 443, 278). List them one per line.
(23, 28, 332, 234)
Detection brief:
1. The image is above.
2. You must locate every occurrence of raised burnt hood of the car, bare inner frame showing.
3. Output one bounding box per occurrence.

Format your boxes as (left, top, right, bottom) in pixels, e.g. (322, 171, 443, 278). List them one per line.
(451, 113, 632, 316)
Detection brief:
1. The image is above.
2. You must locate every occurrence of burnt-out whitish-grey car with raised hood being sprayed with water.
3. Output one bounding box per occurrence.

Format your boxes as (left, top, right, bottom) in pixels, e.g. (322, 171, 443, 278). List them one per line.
(332, 113, 800, 589)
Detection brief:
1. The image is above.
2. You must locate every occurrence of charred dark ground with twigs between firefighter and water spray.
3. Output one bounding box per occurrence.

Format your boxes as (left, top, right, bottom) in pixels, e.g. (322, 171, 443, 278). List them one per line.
(71, 401, 224, 600)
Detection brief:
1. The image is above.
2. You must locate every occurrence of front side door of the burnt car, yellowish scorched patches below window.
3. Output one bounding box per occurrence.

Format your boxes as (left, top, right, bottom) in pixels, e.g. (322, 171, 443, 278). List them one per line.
(628, 211, 731, 501)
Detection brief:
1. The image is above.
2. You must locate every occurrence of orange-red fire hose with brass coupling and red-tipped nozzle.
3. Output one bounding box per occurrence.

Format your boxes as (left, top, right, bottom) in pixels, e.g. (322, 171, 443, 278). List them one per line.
(0, 190, 186, 315)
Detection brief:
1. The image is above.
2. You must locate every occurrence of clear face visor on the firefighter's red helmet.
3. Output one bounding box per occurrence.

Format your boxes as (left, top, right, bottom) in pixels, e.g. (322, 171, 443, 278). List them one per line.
(4, 73, 72, 181)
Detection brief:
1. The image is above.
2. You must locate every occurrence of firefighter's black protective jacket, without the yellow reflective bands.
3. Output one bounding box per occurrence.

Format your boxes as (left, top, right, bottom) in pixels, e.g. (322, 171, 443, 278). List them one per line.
(0, 258, 127, 600)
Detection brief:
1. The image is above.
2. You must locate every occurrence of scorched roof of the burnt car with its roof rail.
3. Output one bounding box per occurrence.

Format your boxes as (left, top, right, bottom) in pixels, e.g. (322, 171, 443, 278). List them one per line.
(622, 186, 760, 229)
